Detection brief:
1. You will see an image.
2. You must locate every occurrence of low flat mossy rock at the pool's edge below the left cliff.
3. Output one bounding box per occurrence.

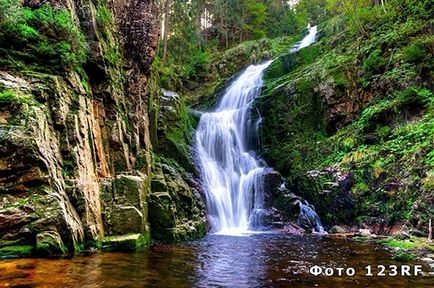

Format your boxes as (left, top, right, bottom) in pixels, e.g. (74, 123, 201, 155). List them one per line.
(101, 233, 151, 251)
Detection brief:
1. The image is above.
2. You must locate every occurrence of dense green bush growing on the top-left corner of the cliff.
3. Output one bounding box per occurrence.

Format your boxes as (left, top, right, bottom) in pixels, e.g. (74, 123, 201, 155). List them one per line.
(0, 0, 87, 70)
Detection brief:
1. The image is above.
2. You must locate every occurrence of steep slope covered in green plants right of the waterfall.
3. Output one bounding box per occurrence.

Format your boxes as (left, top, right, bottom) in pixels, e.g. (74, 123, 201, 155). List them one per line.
(256, 1, 434, 233)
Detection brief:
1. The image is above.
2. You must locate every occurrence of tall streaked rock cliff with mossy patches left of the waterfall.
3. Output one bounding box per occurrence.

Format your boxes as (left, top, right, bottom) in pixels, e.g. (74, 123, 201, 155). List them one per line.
(0, 0, 205, 256)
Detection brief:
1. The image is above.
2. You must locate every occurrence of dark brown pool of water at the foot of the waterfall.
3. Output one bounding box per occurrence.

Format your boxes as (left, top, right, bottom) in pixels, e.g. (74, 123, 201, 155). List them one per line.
(0, 233, 434, 287)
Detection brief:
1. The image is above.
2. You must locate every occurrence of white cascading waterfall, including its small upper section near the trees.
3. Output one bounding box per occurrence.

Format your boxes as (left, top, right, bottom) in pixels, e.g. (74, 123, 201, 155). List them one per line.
(196, 26, 316, 235)
